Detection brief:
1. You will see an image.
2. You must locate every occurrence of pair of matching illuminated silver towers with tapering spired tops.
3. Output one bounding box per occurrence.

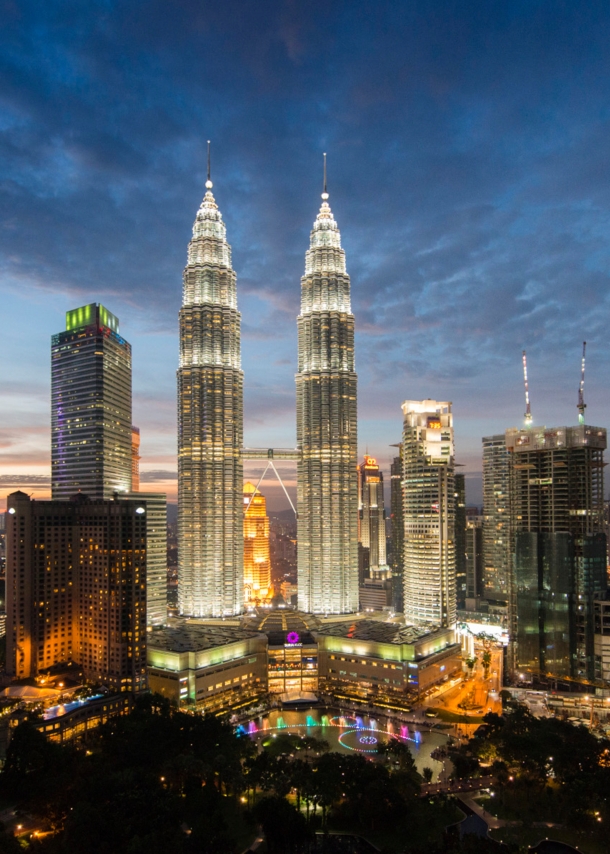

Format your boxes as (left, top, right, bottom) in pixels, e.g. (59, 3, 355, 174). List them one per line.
(178, 162, 358, 617)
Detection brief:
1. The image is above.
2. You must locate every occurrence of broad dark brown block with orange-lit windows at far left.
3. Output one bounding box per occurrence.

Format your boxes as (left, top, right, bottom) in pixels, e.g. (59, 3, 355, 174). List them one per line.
(6, 492, 147, 692)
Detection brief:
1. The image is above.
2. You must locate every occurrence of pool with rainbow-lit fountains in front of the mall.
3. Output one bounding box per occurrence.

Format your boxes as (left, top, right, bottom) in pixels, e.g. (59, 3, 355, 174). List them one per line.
(237, 709, 448, 780)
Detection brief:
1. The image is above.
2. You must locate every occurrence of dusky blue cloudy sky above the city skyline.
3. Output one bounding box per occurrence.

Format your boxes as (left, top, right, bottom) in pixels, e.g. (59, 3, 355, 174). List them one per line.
(0, 0, 610, 508)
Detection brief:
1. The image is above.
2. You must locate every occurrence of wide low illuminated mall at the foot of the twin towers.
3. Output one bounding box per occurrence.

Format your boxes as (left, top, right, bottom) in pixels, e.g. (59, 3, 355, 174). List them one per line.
(148, 611, 462, 714)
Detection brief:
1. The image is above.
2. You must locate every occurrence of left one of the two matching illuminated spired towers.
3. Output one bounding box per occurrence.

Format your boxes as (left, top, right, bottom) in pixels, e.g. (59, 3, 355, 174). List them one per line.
(178, 169, 244, 617)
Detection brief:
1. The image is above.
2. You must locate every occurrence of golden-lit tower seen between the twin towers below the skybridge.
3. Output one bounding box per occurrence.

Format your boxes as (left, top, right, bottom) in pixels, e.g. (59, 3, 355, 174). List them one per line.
(244, 482, 273, 604)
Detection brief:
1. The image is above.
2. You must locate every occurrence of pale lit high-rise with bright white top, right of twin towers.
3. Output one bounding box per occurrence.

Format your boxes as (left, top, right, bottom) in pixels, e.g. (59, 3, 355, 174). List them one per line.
(402, 400, 456, 628)
